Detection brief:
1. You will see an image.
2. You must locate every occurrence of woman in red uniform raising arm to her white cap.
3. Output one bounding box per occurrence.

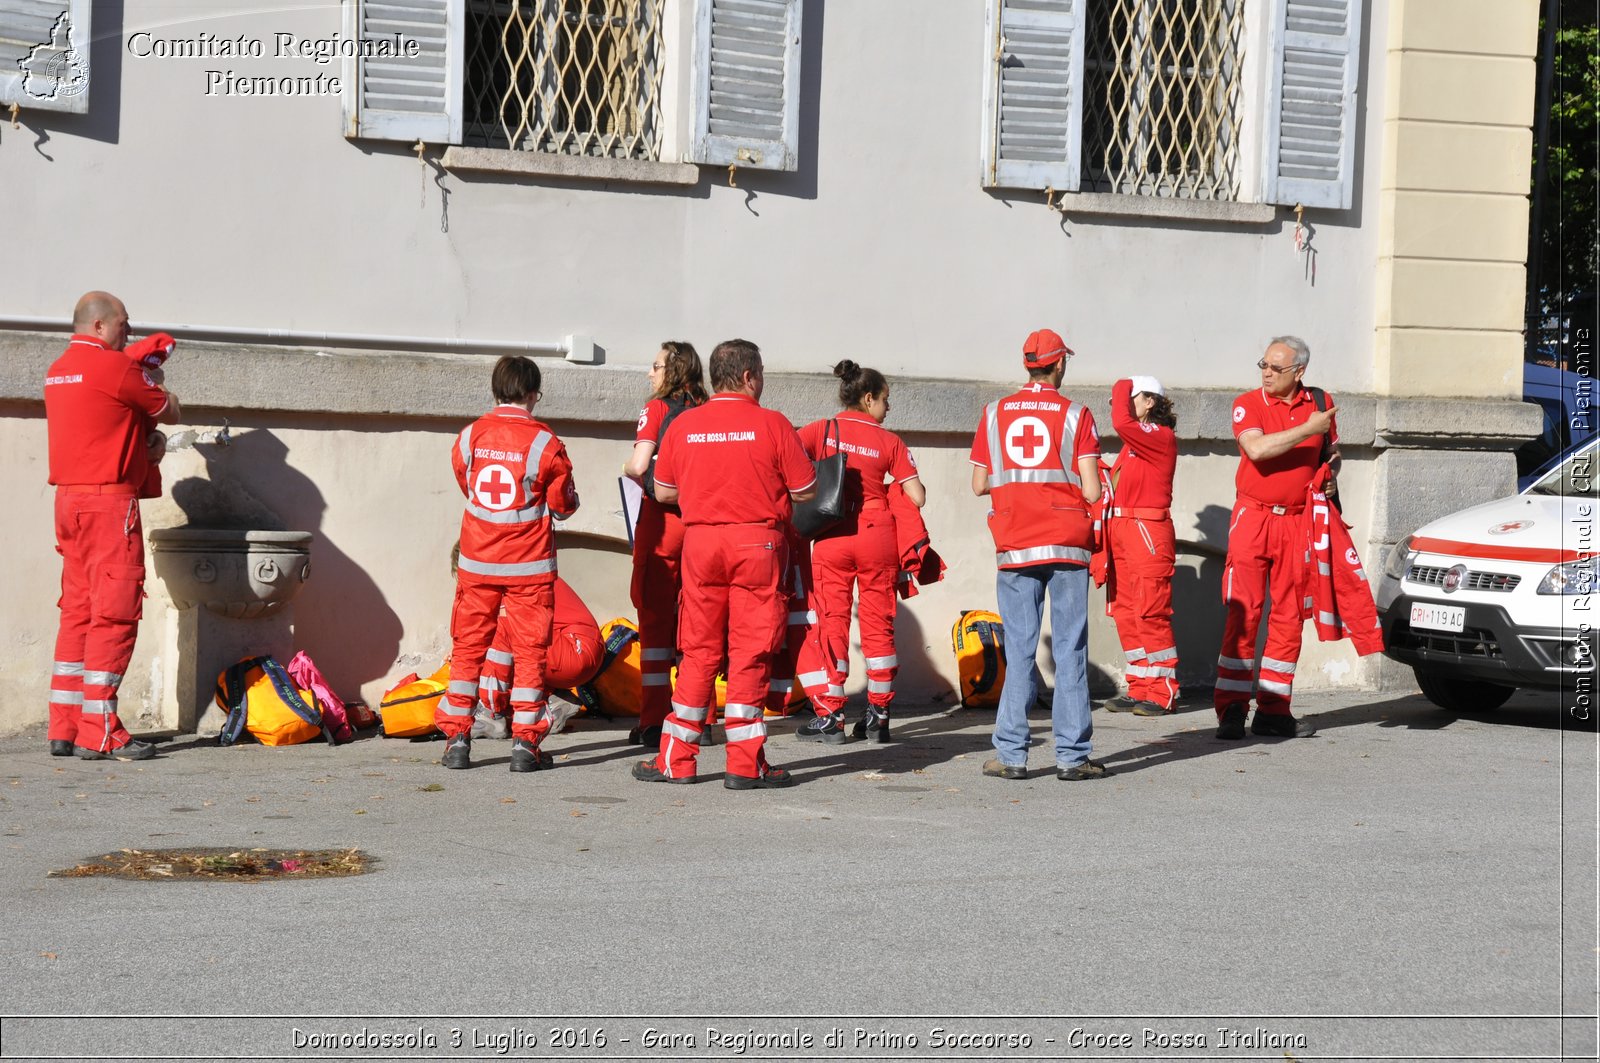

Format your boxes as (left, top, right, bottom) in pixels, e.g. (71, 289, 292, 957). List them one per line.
(1106, 376, 1178, 716)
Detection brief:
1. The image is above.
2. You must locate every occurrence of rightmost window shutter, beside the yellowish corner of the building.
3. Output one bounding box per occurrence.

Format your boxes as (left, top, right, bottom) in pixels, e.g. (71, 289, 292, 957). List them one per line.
(1262, 0, 1362, 210)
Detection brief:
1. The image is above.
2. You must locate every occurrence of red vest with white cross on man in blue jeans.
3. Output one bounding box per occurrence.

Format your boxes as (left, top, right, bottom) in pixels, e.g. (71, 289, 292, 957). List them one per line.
(982, 387, 1094, 568)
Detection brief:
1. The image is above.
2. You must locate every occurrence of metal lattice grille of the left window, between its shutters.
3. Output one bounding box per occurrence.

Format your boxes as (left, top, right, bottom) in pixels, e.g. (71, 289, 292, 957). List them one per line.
(464, 0, 666, 158)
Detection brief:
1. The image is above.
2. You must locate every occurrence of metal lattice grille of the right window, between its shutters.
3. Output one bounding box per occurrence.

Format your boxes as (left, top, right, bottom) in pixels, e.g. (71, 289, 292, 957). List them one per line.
(1083, 0, 1245, 200)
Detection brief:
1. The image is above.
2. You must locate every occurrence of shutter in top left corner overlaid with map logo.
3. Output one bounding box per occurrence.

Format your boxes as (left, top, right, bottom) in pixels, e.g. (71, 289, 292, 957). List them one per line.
(0, 0, 93, 114)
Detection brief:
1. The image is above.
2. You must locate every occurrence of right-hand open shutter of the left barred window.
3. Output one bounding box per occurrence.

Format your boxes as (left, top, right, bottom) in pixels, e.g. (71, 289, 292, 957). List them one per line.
(690, 0, 802, 170)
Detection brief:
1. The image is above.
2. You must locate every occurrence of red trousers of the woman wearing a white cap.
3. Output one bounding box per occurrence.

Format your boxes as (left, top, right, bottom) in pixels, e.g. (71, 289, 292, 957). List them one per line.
(1106, 515, 1178, 709)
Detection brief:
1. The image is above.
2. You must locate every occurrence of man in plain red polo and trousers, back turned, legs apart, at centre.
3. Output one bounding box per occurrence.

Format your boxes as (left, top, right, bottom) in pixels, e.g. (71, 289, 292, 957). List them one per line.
(634, 339, 816, 789)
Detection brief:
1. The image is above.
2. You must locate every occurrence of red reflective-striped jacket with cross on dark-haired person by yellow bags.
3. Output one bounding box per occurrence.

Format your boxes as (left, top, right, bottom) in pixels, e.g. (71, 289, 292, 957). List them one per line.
(451, 405, 578, 584)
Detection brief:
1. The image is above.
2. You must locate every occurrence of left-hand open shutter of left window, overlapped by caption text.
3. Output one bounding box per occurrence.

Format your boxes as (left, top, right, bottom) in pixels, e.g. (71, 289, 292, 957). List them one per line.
(340, 0, 467, 144)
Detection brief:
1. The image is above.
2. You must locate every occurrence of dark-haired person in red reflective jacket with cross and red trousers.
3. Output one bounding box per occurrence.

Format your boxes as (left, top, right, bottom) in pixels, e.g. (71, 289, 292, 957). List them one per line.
(434, 355, 578, 772)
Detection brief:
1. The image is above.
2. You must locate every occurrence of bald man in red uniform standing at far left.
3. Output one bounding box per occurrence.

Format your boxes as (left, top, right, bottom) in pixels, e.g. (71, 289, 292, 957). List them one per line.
(45, 291, 181, 760)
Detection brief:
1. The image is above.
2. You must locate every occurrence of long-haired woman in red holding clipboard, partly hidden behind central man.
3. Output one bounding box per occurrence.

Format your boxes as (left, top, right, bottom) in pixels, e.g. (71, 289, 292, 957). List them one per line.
(622, 339, 707, 749)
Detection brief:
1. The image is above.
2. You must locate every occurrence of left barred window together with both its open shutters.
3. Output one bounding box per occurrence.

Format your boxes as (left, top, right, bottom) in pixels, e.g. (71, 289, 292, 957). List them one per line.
(344, 0, 803, 179)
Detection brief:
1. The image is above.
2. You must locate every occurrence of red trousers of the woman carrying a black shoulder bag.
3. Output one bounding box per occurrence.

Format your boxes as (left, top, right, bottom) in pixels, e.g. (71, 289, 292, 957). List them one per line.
(811, 509, 899, 712)
